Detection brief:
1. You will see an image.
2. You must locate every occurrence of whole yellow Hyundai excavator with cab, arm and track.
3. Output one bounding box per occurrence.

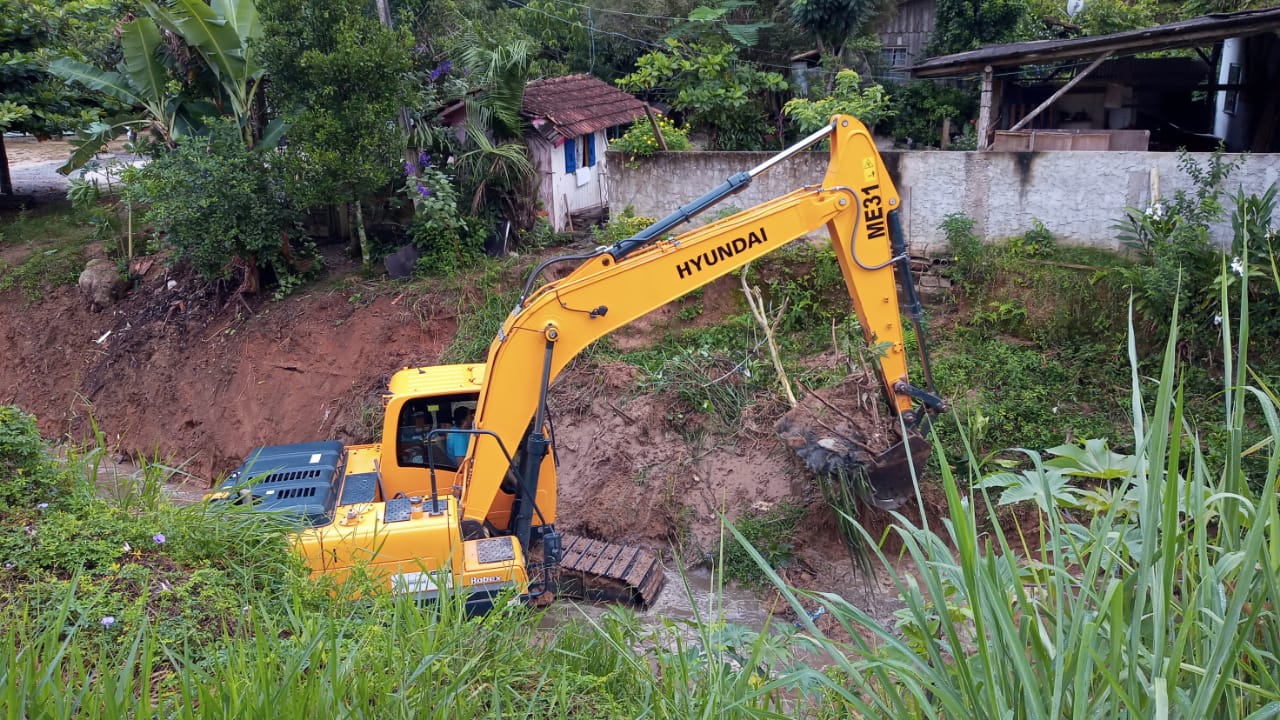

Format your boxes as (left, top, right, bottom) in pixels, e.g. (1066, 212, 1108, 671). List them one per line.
(212, 115, 945, 611)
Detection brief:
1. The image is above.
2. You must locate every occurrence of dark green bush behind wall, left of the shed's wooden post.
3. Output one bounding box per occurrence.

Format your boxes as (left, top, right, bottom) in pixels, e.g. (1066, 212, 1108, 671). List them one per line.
(878, 79, 978, 147)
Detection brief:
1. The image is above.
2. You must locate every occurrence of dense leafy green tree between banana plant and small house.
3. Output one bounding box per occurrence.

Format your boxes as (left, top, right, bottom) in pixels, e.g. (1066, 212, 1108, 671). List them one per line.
(256, 0, 411, 206)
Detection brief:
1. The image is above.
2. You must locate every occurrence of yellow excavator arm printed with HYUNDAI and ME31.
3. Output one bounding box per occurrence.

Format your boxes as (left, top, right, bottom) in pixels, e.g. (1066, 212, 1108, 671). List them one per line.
(462, 115, 941, 532)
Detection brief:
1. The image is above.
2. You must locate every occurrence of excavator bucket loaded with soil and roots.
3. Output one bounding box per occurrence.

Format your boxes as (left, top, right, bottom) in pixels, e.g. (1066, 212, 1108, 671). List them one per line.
(774, 374, 931, 510)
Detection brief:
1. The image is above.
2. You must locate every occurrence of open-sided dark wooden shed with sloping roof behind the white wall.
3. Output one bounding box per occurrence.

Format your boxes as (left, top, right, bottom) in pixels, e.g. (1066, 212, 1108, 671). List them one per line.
(910, 8, 1280, 151)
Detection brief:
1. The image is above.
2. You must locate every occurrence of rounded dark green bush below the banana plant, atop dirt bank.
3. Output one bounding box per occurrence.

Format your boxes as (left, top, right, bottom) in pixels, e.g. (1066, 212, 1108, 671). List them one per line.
(125, 120, 314, 290)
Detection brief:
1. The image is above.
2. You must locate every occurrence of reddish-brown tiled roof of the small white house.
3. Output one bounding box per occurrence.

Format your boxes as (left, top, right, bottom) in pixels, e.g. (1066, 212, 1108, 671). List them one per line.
(522, 74, 644, 141)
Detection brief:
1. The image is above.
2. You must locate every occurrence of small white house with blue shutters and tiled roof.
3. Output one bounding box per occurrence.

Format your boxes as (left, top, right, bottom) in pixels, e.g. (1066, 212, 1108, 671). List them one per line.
(522, 74, 645, 232)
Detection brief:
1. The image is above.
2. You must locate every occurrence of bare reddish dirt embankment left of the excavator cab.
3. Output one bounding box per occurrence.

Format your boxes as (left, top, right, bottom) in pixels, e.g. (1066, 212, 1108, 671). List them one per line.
(0, 278, 454, 479)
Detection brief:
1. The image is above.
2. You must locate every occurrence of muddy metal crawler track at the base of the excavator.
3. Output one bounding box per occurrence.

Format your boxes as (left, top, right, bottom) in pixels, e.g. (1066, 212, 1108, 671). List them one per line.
(557, 534, 667, 607)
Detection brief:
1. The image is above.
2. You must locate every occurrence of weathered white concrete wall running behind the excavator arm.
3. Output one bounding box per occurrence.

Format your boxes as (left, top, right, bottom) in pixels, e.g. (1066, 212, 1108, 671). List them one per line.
(609, 151, 1280, 254)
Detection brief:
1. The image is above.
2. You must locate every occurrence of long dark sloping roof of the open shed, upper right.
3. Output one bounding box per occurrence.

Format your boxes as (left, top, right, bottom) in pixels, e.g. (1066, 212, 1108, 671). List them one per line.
(909, 8, 1280, 77)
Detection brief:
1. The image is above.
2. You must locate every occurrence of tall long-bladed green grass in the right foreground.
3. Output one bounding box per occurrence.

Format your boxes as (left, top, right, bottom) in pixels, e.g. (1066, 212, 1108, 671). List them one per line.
(742, 252, 1280, 719)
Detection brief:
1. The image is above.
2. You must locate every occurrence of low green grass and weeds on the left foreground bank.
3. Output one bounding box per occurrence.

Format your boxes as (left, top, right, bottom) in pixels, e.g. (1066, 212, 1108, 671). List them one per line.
(0, 435, 790, 720)
